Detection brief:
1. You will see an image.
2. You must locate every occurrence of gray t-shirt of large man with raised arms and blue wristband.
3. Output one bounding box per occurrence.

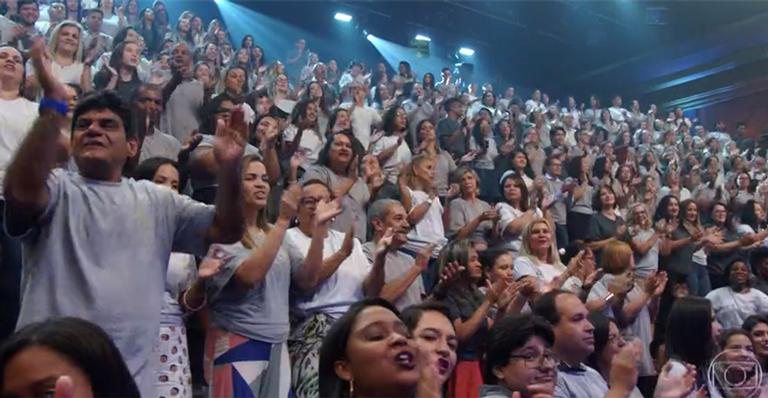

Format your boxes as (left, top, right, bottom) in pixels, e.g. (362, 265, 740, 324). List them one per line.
(5, 169, 214, 396)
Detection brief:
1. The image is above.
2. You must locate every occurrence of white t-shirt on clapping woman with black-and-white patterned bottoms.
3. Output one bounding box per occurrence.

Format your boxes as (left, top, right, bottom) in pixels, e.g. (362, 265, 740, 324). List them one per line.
(283, 228, 371, 318)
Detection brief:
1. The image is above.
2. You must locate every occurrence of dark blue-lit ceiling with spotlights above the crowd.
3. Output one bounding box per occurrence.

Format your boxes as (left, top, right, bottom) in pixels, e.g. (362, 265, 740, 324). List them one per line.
(225, 0, 768, 107)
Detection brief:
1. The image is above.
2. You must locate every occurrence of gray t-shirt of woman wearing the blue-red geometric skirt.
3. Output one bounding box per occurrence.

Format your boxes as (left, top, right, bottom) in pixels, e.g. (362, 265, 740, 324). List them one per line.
(205, 242, 291, 344)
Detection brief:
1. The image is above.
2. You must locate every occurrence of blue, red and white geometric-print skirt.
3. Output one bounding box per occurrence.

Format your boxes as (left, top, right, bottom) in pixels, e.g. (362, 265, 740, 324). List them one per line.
(204, 327, 291, 398)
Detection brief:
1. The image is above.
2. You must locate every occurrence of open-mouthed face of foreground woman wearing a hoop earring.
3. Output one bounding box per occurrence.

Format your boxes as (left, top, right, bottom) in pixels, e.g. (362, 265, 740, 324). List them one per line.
(334, 306, 420, 397)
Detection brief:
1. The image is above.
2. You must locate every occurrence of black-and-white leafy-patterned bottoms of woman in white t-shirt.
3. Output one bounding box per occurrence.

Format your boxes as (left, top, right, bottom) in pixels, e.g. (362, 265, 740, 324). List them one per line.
(288, 314, 334, 398)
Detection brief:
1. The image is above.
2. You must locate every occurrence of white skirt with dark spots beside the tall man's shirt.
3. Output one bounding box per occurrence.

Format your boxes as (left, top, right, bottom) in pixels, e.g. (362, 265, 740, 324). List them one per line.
(155, 326, 192, 398)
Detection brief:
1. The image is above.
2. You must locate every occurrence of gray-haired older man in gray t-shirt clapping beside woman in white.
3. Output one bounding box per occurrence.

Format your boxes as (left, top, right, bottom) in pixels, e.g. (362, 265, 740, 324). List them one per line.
(363, 199, 434, 310)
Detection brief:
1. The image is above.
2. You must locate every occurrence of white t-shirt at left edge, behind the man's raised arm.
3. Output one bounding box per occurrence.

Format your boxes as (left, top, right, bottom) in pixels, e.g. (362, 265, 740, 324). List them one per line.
(0, 97, 39, 188)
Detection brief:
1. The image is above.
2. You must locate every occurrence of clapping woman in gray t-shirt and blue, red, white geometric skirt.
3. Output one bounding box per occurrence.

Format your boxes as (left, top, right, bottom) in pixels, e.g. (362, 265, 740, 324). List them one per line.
(205, 155, 301, 397)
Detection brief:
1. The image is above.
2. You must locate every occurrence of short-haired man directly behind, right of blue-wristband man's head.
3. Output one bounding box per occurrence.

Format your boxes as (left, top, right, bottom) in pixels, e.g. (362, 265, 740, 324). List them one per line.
(134, 84, 181, 162)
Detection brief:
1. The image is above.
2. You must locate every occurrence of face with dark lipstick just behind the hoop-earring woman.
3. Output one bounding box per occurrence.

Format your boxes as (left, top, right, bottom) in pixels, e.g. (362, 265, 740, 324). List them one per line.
(413, 311, 459, 385)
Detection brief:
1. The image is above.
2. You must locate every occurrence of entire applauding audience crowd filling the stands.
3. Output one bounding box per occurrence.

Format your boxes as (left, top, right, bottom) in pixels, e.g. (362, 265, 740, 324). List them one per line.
(0, 0, 768, 398)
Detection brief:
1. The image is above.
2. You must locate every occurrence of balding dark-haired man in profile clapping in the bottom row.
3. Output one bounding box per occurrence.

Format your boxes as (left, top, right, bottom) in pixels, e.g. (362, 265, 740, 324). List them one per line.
(533, 290, 639, 398)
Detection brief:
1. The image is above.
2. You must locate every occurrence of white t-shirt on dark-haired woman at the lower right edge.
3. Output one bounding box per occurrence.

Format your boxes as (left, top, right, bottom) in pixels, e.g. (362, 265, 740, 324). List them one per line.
(706, 286, 768, 329)
